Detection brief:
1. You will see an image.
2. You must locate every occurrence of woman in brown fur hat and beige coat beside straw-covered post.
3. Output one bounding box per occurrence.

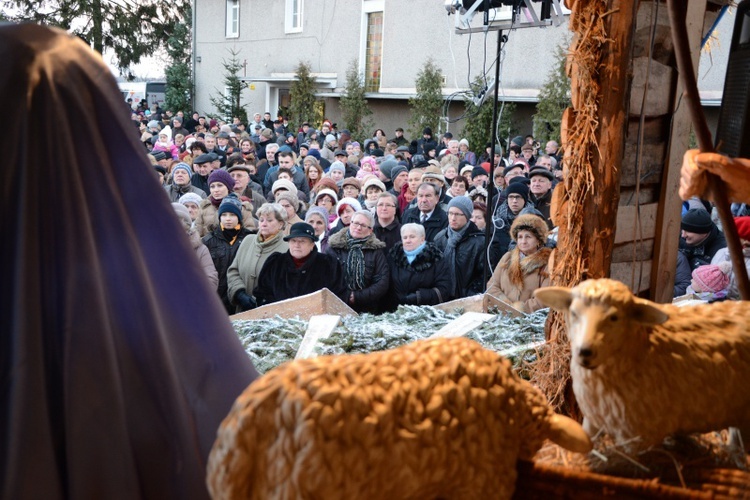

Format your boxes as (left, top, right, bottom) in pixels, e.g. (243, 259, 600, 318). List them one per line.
(487, 214, 552, 313)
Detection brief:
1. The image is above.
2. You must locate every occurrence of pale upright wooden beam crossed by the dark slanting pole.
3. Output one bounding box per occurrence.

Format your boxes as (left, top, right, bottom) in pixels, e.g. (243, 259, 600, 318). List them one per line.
(651, 0, 706, 303)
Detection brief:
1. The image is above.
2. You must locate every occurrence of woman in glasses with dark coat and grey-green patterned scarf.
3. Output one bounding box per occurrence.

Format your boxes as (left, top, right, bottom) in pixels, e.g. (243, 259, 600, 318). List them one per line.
(326, 210, 390, 313)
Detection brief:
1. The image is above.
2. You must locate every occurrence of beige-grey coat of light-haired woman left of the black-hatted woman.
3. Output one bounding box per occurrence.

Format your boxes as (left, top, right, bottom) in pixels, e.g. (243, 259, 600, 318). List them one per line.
(227, 231, 289, 304)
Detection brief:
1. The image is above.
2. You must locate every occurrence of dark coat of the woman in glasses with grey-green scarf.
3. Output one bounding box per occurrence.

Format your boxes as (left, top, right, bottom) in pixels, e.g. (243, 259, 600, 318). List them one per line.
(326, 229, 390, 313)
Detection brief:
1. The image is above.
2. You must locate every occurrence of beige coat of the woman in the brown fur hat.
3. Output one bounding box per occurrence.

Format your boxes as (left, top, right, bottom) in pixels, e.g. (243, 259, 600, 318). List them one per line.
(487, 247, 552, 313)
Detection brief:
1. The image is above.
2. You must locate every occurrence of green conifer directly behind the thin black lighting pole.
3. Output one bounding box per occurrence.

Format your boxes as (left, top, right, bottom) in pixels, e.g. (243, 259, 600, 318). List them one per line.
(461, 79, 517, 158)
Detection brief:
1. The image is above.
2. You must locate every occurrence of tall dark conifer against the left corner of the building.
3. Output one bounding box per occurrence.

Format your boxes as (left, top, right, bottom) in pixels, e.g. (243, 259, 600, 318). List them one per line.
(165, 5, 193, 114)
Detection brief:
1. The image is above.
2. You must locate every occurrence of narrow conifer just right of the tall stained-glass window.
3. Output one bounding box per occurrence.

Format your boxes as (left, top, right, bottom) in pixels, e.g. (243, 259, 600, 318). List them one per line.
(409, 59, 443, 137)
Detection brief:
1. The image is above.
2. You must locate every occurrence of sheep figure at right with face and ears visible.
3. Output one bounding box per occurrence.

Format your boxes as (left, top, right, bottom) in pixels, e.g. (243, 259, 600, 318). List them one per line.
(535, 279, 750, 451)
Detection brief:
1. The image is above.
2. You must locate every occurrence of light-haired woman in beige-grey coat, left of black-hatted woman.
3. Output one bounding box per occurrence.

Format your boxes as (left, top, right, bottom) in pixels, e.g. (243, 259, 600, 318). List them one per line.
(227, 203, 289, 312)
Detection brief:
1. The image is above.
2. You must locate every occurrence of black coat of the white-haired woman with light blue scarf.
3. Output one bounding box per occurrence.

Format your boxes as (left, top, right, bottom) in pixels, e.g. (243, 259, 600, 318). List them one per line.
(388, 242, 453, 311)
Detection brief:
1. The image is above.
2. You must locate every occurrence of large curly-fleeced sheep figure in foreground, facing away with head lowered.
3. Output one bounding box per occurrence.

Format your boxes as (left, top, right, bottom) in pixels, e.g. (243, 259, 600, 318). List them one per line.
(208, 338, 591, 499)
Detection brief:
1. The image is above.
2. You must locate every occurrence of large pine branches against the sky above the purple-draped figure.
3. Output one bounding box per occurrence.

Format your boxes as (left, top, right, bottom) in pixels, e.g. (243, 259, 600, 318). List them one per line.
(4, 0, 190, 73)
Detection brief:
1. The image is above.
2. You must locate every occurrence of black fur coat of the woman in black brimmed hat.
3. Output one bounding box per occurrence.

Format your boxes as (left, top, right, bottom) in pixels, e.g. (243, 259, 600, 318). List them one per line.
(253, 248, 349, 306)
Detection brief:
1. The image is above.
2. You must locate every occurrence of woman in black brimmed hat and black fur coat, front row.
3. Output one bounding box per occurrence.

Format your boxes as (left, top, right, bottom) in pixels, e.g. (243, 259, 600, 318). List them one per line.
(253, 222, 349, 306)
